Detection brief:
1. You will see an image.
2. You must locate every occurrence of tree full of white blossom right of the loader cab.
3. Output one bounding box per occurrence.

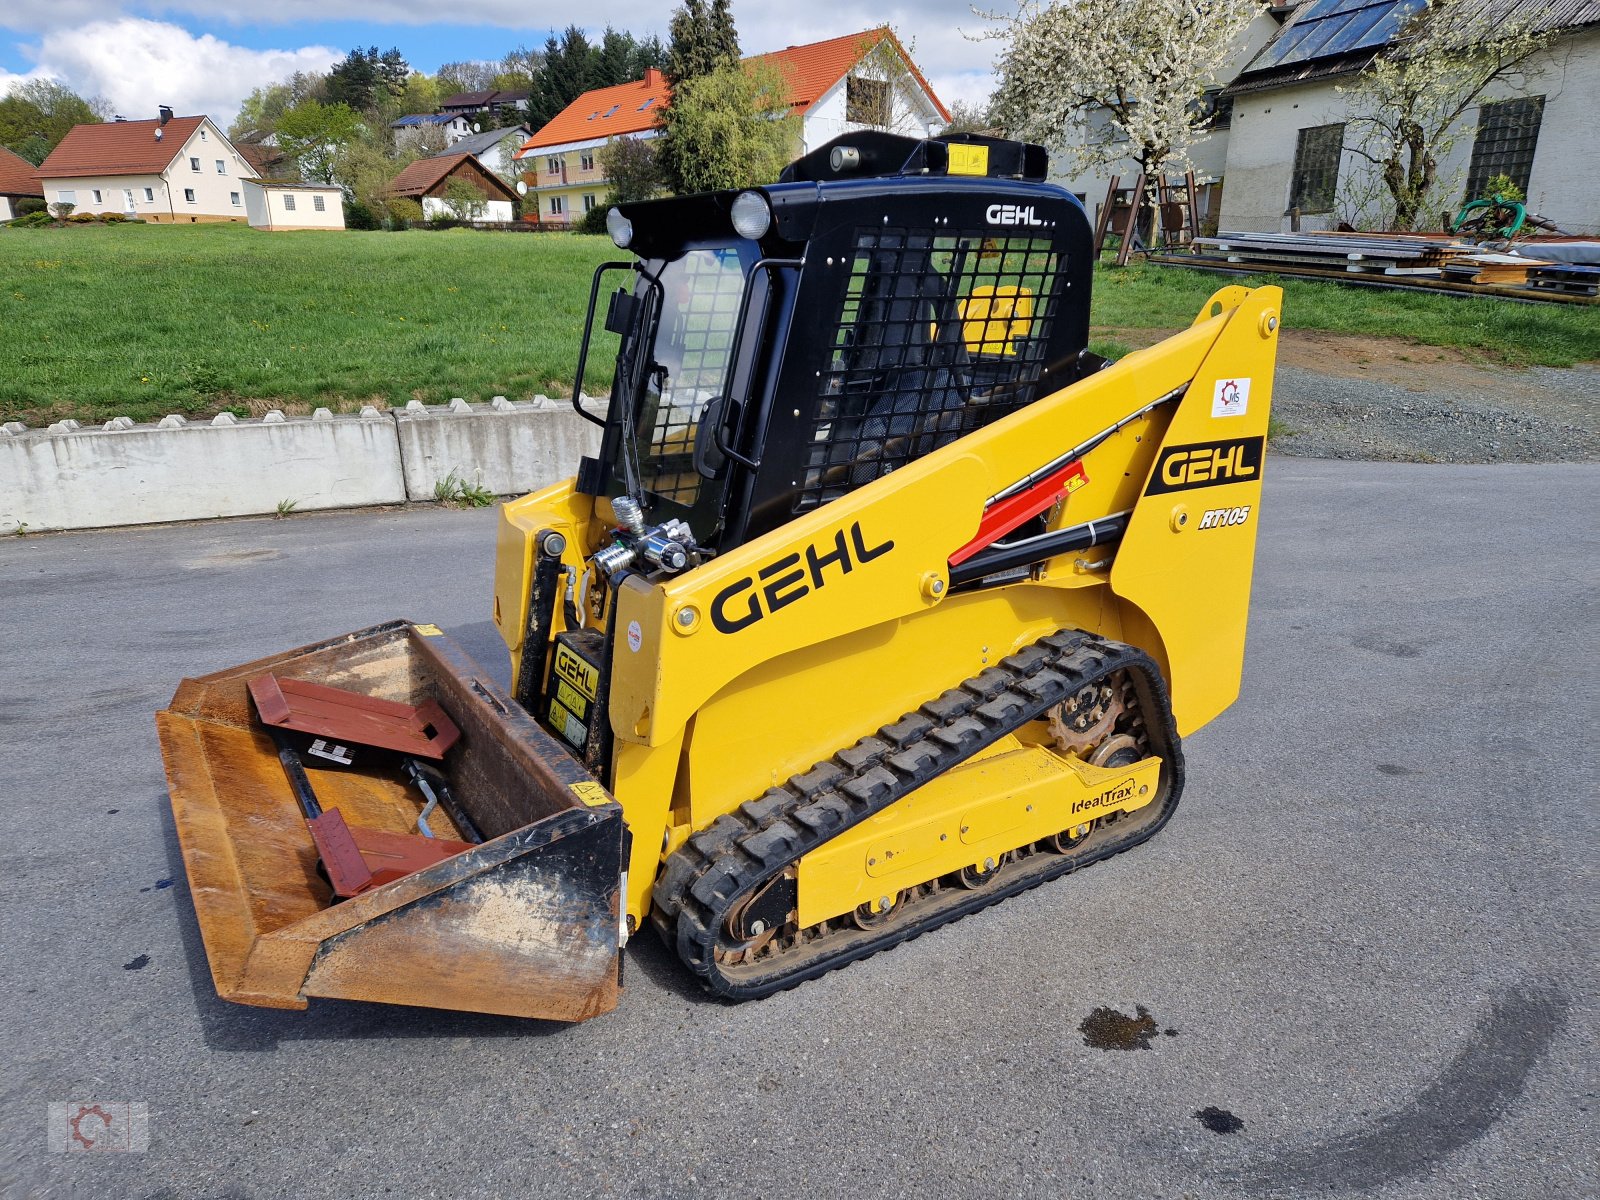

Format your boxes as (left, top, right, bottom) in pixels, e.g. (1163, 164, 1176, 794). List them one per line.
(989, 0, 1261, 174)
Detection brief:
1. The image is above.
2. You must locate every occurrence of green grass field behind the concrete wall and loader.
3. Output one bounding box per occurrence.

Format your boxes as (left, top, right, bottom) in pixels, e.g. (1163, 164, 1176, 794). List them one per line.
(0, 226, 1600, 426)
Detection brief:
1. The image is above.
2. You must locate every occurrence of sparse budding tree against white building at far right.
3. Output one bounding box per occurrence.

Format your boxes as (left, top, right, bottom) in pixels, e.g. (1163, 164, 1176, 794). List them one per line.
(1341, 0, 1554, 229)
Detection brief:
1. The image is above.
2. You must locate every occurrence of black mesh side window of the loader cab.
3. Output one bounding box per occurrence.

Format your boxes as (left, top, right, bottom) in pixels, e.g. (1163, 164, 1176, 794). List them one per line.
(795, 227, 1062, 510)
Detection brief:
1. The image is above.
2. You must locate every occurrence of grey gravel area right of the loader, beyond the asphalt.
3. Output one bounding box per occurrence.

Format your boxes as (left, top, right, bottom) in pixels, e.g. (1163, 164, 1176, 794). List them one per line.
(1272, 363, 1600, 462)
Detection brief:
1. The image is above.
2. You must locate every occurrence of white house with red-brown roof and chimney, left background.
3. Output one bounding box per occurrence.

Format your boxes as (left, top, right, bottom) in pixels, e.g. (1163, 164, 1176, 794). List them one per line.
(38, 109, 254, 224)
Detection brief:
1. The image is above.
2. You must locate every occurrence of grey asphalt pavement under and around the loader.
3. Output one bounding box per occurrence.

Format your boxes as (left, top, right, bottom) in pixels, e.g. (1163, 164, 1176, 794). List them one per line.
(0, 458, 1600, 1200)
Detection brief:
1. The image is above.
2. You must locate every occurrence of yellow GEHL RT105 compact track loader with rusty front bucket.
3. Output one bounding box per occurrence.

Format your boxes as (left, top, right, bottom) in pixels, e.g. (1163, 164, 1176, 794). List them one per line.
(158, 133, 1282, 1021)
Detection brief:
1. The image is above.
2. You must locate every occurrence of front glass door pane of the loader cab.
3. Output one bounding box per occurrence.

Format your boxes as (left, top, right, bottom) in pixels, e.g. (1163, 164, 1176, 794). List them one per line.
(638, 248, 744, 507)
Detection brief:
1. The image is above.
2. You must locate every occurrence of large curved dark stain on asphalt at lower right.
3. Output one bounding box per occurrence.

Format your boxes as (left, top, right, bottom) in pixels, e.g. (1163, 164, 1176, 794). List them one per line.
(1227, 987, 1570, 1192)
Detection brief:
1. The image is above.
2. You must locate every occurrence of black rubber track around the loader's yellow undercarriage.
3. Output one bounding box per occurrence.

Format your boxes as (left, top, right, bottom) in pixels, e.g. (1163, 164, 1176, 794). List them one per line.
(651, 630, 1184, 1000)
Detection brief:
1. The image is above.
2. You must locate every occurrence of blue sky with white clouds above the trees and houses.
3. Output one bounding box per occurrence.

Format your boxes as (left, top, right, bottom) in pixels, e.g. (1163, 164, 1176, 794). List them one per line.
(0, 0, 1008, 125)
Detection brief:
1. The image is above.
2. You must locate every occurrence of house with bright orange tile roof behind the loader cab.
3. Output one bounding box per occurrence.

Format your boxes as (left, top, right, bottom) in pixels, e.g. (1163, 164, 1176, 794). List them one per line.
(517, 27, 950, 226)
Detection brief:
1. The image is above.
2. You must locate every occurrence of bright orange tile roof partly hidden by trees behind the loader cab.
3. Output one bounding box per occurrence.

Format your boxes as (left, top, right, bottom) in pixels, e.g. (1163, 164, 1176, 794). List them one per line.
(517, 26, 950, 158)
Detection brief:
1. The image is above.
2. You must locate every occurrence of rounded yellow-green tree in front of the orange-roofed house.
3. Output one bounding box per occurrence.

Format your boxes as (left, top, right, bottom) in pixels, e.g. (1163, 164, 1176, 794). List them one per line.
(658, 62, 800, 192)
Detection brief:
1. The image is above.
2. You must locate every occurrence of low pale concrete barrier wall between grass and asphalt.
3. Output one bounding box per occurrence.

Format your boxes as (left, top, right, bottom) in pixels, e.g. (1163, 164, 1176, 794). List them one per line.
(0, 397, 600, 534)
